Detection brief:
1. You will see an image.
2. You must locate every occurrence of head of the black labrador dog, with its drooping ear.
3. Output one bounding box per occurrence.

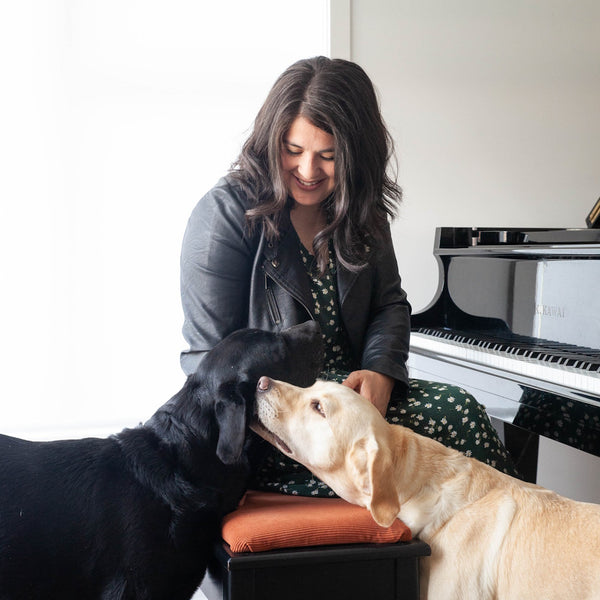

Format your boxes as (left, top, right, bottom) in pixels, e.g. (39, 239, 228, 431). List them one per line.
(148, 321, 323, 464)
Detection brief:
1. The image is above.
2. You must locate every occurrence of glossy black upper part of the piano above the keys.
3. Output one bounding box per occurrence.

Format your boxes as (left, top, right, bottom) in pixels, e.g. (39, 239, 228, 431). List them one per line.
(412, 227, 600, 349)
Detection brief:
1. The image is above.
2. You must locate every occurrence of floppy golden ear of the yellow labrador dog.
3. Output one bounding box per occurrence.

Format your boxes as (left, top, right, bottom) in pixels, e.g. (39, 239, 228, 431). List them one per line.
(348, 436, 400, 527)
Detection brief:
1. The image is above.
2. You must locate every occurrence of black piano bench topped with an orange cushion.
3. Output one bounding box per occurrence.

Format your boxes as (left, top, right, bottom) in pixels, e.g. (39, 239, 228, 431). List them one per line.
(200, 491, 430, 600)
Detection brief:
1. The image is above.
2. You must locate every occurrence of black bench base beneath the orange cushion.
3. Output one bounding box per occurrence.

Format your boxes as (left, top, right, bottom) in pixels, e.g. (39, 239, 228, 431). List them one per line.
(200, 540, 431, 600)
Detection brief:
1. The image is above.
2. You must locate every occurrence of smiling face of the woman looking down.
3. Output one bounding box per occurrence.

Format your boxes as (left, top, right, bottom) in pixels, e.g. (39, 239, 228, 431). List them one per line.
(281, 117, 335, 206)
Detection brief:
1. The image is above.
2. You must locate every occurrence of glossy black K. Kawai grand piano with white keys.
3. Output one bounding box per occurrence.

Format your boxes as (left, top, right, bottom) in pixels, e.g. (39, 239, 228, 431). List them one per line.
(409, 227, 600, 503)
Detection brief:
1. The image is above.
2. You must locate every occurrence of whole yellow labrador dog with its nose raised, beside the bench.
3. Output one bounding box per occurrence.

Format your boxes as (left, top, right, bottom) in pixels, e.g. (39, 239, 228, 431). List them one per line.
(252, 377, 600, 600)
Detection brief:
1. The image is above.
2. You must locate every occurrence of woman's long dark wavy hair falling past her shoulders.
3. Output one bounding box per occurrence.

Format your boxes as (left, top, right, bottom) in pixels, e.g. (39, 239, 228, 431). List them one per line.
(231, 56, 402, 273)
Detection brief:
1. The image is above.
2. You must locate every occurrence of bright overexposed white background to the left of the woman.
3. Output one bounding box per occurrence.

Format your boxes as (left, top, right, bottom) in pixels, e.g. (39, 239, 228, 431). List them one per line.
(0, 0, 329, 439)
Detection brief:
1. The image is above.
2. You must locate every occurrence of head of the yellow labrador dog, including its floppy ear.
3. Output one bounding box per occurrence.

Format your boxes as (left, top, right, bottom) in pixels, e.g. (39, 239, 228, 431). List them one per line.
(251, 377, 400, 527)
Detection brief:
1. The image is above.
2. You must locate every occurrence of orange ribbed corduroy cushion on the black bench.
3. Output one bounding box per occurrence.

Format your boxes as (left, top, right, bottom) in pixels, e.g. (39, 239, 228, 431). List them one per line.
(222, 491, 412, 552)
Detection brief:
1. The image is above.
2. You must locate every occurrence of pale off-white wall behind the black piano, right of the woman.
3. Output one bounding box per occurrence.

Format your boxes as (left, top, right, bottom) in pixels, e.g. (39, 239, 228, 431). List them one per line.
(332, 0, 600, 311)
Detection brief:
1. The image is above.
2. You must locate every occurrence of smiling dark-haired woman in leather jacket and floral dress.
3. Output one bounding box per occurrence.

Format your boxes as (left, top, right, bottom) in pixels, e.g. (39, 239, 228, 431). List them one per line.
(181, 57, 511, 495)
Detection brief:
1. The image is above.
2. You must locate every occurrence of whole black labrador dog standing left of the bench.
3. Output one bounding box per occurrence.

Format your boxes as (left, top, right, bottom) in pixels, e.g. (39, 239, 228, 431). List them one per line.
(0, 322, 322, 600)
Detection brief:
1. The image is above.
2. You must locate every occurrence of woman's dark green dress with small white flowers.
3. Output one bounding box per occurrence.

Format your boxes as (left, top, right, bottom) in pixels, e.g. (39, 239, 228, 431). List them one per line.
(252, 241, 517, 497)
